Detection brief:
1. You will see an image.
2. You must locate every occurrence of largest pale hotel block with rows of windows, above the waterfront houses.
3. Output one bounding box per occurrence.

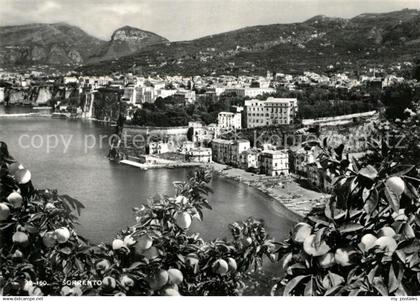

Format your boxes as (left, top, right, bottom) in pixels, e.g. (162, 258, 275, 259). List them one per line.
(244, 97, 297, 128)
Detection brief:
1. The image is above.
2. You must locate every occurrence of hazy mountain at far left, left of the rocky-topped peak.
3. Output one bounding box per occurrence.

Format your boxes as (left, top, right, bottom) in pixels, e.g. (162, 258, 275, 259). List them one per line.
(0, 23, 105, 67)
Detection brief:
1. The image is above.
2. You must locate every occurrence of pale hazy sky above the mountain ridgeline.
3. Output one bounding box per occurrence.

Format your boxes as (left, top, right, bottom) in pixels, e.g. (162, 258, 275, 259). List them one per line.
(0, 0, 420, 41)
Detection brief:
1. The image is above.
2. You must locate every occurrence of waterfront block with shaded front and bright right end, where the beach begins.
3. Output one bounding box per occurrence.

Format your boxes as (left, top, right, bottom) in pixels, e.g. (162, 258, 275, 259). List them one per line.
(211, 139, 251, 166)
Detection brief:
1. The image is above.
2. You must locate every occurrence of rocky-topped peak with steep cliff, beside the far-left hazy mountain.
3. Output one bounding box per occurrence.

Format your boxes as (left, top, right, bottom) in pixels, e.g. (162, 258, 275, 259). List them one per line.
(90, 26, 168, 61)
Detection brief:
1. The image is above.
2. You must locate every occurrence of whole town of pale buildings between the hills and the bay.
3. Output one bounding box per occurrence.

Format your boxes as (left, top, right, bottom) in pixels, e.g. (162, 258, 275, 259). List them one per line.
(0, 62, 420, 202)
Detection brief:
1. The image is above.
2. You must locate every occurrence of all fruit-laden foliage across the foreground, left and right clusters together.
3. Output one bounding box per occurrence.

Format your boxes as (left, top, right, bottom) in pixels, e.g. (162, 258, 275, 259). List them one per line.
(0, 104, 420, 295)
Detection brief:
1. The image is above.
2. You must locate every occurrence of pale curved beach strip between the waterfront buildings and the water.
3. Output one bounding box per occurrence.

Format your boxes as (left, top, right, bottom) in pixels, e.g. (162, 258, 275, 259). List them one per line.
(209, 162, 330, 219)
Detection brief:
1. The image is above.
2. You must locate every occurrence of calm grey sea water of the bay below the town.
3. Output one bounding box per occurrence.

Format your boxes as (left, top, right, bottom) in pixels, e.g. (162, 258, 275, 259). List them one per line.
(0, 107, 295, 242)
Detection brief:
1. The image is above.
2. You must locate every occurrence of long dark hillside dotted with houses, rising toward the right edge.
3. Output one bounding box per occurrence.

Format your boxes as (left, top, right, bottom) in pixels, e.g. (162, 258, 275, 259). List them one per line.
(80, 9, 420, 75)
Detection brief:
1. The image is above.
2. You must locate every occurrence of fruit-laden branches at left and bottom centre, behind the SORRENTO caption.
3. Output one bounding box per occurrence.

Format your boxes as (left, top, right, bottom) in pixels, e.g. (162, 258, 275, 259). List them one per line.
(0, 163, 274, 295)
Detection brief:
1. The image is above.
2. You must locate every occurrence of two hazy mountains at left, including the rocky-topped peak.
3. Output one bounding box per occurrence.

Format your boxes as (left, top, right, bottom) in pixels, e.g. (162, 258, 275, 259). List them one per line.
(0, 23, 168, 67)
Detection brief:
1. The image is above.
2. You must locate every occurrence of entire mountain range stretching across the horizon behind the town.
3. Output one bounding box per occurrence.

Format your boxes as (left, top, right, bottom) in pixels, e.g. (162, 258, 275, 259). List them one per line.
(0, 9, 420, 75)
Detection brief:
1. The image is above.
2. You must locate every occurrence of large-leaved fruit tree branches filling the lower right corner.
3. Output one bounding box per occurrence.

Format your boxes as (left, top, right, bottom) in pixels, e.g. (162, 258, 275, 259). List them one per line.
(272, 116, 420, 296)
